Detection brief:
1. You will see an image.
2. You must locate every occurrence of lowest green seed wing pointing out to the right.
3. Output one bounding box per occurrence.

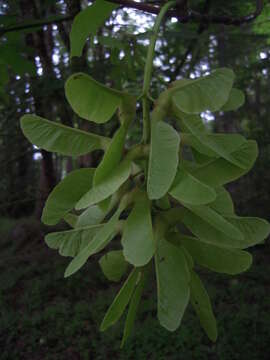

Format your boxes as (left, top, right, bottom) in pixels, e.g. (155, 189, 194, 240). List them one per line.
(175, 234, 252, 275)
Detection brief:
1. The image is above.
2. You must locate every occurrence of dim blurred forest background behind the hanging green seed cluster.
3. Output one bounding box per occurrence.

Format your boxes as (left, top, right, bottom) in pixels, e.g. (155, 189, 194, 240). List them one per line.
(0, 0, 270, 360)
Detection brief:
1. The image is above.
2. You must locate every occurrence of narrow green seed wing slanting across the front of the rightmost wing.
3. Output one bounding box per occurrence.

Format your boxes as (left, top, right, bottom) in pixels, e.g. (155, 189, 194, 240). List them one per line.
(184, 203, 244, 240)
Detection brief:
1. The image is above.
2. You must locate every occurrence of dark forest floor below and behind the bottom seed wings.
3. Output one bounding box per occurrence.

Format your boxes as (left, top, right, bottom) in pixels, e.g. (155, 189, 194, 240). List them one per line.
(0, 218, 270, 360)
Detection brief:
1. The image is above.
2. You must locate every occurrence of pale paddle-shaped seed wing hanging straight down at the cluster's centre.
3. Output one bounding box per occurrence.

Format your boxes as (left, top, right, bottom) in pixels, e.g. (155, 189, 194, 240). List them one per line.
(122, 193, 155, 266)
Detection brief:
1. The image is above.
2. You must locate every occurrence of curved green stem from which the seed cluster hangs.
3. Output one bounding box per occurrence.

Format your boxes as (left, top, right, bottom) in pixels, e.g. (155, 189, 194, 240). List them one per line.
(142, 1, 176, 144)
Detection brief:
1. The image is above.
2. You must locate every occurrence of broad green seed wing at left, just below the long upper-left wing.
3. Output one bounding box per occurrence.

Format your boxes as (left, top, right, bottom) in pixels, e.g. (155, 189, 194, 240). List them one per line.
(41, 168, 95, 225)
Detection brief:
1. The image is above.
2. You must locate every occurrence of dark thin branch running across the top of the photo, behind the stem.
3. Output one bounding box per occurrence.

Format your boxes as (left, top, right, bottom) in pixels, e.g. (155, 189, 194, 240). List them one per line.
(0, 0, 263, 36)
